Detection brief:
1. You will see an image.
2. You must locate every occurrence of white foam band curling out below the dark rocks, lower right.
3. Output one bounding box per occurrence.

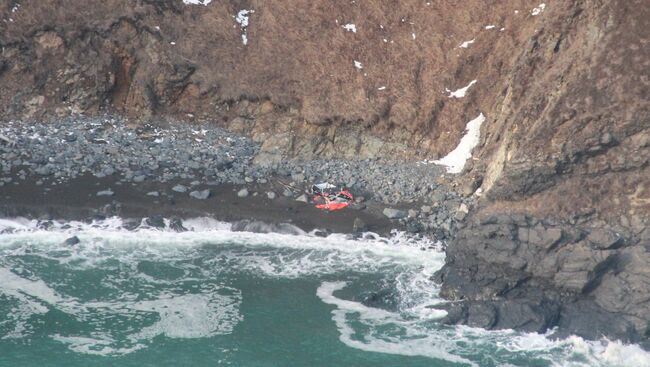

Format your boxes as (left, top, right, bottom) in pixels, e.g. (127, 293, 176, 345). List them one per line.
(316, 282, 650, 367)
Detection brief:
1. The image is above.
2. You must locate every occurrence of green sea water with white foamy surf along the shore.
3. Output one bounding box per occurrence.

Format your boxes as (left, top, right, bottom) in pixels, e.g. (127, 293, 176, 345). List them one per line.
(0, 218, 650, 367)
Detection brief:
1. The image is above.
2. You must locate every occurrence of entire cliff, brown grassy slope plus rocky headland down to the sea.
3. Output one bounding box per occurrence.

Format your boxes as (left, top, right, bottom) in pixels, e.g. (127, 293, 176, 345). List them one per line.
(0, 0, 650, 340)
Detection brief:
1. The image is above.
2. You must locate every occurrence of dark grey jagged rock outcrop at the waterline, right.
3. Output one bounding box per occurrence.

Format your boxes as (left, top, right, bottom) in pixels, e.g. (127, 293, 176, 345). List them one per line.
(437, 215, 650, 342)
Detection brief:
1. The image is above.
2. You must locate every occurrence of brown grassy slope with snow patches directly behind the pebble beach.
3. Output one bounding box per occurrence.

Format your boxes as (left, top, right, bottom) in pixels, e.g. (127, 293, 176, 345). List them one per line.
(0, 0, 554, 158)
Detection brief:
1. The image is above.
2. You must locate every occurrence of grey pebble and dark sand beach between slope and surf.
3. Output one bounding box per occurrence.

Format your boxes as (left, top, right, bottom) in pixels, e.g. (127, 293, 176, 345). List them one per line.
(0, 117, 473, 240)
